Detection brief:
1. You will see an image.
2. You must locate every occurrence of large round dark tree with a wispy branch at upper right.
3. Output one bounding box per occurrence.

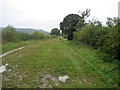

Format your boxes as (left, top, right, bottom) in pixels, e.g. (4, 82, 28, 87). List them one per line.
(60, 9, 90, 40)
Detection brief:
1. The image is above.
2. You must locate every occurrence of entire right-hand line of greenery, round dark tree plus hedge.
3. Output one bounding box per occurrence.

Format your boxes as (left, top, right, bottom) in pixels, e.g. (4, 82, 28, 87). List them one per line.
(60, 9, 120, 61)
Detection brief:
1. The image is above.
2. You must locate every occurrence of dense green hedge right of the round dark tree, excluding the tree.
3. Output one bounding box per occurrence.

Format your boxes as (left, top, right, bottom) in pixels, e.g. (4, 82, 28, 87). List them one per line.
(73, 18, 120, 61)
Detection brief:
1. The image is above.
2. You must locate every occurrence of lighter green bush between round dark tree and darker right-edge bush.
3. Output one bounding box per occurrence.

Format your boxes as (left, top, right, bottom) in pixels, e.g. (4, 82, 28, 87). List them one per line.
(74, 25, 106, 48)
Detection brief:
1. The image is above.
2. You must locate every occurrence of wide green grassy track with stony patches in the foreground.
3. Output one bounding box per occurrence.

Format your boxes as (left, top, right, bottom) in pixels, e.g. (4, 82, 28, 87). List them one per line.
(3, 39, 118, 88)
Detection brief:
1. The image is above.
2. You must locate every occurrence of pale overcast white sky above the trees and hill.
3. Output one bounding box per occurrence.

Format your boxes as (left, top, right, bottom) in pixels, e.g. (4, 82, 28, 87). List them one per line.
(0, 0, 120, 32)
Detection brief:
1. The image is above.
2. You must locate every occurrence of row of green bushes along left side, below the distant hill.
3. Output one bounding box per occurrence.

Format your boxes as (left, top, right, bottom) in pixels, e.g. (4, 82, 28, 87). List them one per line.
(2, 25, 55, 44)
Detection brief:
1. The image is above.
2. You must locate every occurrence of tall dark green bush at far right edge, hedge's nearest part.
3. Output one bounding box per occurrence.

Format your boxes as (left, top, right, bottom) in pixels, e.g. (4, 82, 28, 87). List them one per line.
(103, 18, 120, 61)
